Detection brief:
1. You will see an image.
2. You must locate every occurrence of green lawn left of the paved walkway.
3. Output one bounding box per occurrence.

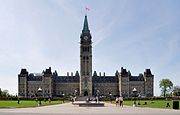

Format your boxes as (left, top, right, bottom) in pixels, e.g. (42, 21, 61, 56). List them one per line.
(0, 100, 62, 108)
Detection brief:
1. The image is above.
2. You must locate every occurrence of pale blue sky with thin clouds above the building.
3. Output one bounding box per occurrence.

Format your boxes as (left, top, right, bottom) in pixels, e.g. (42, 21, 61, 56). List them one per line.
(0, 0, 180, 96)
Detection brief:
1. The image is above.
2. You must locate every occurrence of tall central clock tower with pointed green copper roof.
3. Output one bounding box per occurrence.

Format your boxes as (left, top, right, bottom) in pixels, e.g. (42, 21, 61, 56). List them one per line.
(80, 16, 92, 96)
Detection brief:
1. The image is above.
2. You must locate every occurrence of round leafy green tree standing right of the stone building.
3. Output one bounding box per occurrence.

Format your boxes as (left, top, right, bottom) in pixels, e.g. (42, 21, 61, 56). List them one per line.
(159, 79, 173, 97)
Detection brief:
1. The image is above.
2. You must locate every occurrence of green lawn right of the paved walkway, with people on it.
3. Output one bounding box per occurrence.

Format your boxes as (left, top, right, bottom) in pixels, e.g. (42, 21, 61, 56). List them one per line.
(113, 100, 180, 109)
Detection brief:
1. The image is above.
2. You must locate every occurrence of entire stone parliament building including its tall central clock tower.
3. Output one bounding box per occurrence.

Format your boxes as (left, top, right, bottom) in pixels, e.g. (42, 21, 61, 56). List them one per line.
(18, 16, 154, 98)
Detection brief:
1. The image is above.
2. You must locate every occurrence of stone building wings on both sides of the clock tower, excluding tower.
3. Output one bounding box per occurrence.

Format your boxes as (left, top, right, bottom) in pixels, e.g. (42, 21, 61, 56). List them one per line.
(18, 69, 154, 97)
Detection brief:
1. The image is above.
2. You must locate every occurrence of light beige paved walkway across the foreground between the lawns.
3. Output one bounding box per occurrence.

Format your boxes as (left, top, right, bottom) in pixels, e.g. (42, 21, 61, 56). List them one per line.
(0, 103, 180, 115)
